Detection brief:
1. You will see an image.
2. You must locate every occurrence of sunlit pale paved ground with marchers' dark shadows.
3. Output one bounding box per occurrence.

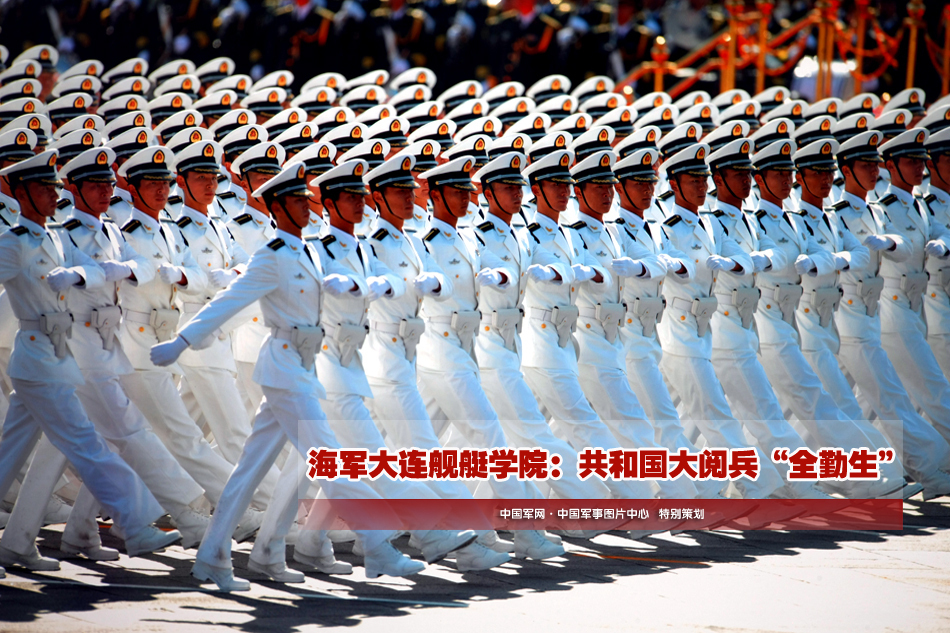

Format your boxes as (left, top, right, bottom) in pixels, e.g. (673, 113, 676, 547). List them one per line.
(0, 502, 950, 633)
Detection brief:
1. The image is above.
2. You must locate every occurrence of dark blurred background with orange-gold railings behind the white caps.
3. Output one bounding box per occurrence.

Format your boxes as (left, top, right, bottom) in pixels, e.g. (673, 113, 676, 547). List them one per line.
(0, 0, 950, 100)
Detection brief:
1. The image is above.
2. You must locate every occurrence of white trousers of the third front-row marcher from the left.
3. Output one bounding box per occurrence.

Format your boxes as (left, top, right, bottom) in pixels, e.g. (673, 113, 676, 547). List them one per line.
(119, 370, 270, 509)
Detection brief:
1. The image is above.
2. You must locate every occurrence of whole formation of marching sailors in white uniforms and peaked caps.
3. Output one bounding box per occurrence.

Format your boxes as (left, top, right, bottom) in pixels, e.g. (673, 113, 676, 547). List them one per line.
(0, 46, 950, 590)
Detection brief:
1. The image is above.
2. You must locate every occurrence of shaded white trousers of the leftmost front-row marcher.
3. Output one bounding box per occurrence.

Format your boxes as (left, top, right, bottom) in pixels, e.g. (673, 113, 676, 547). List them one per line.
(0, 378, 164, 537)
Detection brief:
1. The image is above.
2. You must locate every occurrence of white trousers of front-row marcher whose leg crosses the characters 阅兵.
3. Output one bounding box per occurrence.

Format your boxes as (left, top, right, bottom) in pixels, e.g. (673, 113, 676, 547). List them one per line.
(660, 353, 785, 499)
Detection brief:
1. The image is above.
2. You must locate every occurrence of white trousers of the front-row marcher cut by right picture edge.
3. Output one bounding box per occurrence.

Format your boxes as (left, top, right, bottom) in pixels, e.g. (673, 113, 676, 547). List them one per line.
(881, 314, 950, 442)
